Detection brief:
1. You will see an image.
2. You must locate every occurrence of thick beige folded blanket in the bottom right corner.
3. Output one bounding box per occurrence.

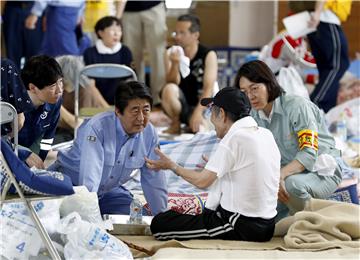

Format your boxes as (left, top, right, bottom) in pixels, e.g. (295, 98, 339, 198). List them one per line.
(279, 199, 360, 249)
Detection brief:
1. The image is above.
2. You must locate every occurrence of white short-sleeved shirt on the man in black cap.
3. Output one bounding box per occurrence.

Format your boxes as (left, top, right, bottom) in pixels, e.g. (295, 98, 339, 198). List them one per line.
(205, 116, 281, 219)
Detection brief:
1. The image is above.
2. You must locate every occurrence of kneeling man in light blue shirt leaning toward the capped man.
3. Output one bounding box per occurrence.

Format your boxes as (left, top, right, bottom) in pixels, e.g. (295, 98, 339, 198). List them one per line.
(49, 81, 167, 215)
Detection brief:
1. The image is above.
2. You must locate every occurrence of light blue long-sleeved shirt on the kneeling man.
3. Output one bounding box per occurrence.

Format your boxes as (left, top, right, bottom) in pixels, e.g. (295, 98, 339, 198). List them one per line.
(57, 112, 167, 215)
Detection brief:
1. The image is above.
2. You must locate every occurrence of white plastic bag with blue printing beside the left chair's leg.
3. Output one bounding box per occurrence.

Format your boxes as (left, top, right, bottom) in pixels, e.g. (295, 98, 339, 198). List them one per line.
(59, 212, 133, 259)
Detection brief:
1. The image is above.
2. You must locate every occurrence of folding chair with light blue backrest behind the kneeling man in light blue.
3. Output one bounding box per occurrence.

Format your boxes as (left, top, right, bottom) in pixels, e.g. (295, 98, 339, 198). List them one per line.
(74, 63, 137, 135)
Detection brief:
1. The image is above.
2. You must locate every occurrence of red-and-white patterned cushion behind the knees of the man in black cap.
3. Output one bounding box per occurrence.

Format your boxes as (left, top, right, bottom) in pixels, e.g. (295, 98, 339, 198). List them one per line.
(144, 193, 207, 215)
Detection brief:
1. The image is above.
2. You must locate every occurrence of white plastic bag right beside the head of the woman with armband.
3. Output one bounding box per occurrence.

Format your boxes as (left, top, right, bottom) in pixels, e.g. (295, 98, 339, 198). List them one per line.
(277, 66, 309, 99)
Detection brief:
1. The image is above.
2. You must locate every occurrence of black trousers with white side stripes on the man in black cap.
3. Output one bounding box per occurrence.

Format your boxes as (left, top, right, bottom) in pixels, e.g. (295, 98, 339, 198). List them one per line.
(150, 206, 275, 242)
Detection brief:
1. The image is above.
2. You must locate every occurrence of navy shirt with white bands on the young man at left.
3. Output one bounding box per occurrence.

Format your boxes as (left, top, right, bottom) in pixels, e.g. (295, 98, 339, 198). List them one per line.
(19, 98, 62, 160)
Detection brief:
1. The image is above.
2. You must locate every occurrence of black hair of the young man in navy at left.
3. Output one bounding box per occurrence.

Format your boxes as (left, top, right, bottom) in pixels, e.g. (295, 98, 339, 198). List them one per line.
(21, 55, 63, 89)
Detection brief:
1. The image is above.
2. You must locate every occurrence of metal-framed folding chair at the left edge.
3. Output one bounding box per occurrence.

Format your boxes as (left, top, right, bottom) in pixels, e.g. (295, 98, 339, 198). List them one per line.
(0, 102, 61, 259)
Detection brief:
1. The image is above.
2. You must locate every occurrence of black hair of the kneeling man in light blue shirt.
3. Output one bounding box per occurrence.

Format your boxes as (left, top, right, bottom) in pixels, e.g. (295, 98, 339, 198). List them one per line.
(114, 81, 153, 114)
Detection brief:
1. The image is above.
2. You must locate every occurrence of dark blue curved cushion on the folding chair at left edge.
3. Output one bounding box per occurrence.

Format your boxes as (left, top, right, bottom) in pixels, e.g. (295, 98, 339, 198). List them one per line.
(0, 140, 74, 195)
